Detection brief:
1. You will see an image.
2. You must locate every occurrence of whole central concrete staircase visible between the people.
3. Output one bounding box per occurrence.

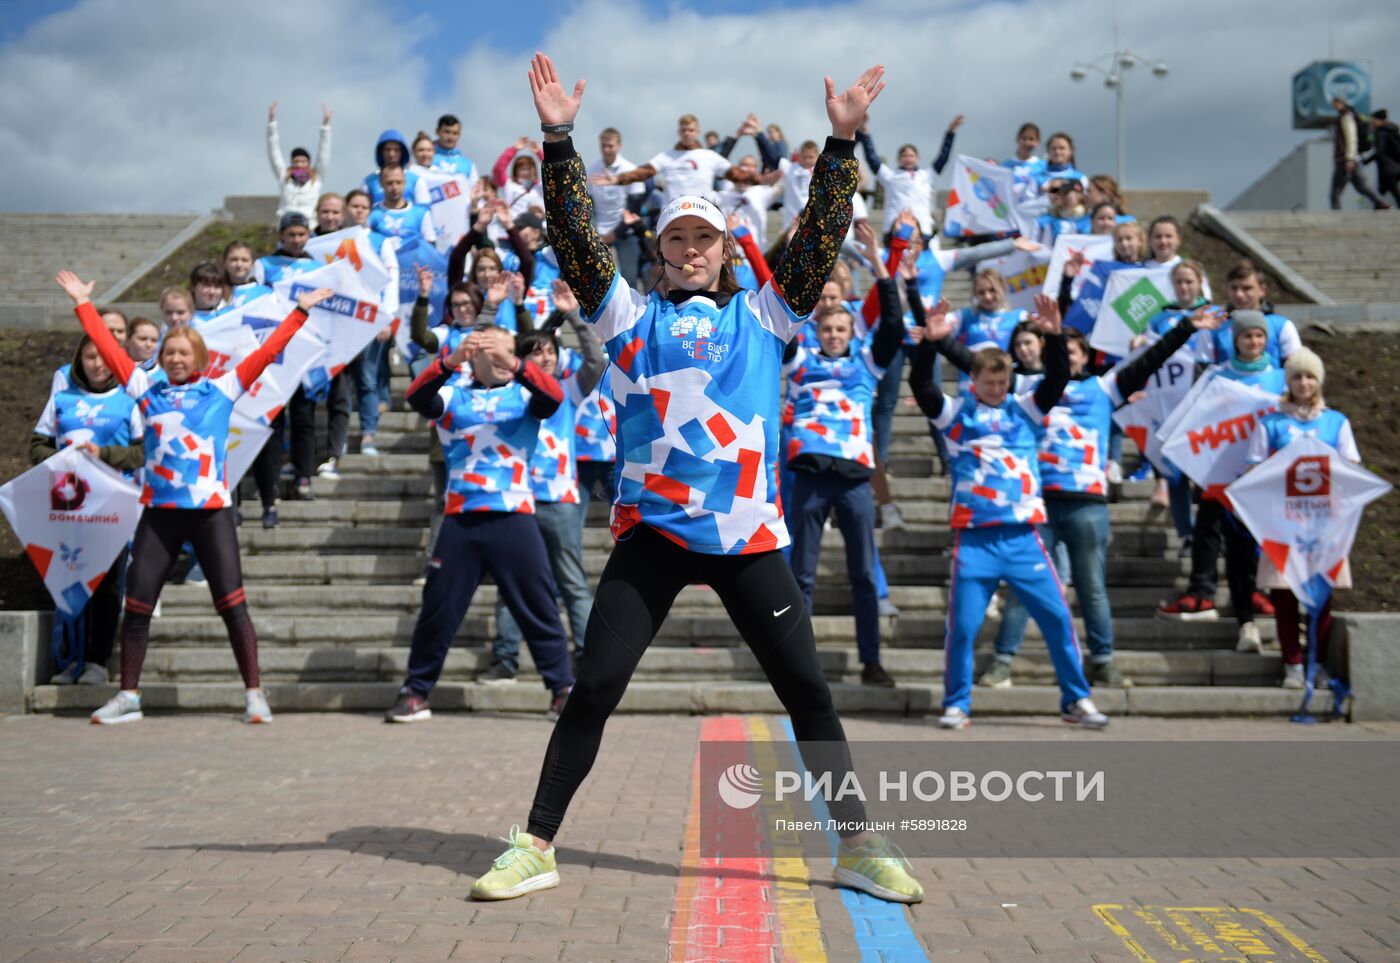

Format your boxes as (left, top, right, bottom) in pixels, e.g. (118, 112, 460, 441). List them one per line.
(34, 351, 1327, 715)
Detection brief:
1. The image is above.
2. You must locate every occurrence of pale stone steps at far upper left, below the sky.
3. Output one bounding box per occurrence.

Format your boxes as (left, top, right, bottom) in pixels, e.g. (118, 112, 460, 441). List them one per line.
(0, 213, 207, 328)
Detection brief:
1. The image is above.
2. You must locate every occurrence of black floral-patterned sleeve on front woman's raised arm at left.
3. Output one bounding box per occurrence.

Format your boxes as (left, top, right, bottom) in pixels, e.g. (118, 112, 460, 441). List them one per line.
(543, 140, 618, 318)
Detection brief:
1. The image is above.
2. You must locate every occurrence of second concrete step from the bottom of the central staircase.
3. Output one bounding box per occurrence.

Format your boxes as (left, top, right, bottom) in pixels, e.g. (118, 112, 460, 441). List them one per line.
(126, 645, 1282, 687)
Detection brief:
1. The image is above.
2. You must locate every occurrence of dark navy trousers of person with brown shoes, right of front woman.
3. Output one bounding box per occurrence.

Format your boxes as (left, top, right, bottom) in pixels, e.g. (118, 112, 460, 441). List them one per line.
(785, 472, 879, 662)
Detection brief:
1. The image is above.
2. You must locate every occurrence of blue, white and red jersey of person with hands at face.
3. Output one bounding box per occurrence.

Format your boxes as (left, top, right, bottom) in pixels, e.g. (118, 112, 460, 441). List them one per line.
(437, 378, 546, 515)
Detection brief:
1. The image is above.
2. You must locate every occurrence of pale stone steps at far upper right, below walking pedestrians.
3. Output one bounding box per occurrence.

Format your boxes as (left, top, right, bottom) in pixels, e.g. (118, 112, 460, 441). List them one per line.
(1229, 210, 1400, 304)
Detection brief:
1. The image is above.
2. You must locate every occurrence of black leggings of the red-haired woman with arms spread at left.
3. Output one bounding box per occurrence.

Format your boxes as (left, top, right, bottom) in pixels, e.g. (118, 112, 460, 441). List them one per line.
(122, 506, 260, 689)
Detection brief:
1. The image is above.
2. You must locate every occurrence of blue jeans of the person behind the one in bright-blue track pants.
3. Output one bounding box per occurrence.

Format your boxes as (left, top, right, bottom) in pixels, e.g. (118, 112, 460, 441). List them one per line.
(997, 498, 1113, 662)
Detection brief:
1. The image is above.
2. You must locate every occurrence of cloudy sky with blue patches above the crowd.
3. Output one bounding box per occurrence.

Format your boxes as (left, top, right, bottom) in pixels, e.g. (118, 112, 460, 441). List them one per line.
(0, 0, 1400, 211)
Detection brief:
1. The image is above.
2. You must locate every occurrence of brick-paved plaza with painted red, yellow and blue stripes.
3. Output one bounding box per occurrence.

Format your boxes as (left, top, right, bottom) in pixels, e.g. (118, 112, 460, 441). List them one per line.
(0, 714, 1400, 963)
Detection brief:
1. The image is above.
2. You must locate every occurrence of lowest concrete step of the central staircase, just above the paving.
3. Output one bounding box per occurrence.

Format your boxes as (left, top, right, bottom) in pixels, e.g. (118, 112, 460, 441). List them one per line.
(31, 682, 1331, 716)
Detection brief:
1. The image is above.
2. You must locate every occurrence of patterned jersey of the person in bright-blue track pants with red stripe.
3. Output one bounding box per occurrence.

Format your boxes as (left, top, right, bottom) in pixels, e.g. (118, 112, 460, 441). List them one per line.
(932, 393, 1046, 528)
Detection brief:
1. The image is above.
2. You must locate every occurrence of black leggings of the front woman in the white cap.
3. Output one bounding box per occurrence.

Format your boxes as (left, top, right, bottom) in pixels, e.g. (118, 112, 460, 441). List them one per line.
(529, 525, 865, 840)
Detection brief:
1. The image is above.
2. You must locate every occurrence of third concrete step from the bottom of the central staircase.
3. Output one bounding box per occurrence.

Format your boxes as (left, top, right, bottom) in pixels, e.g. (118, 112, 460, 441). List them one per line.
(151, 613, 1274, 651)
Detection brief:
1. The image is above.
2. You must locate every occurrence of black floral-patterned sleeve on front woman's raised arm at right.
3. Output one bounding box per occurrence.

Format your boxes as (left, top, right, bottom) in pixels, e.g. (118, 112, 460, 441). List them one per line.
(772, 137, 860, 316)
